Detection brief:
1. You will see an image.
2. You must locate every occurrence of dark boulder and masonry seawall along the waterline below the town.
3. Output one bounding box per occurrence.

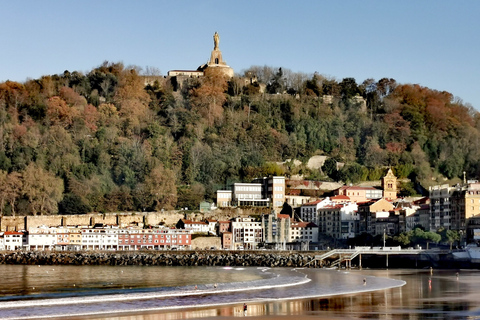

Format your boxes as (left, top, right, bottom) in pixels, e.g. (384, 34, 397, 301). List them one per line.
(0, 250, 472, 269)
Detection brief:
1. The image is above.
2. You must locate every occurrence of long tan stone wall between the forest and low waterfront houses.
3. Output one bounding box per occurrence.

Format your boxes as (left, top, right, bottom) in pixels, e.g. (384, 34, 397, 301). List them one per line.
(0, 209, 252, 231)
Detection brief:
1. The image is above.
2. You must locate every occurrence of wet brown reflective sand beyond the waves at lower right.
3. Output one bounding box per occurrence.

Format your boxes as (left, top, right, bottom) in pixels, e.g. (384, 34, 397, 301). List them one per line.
(91, 270, 480, 320)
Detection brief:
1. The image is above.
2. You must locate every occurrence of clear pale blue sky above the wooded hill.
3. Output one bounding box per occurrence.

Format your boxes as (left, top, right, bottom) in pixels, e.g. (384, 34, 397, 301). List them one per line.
(0, 0, 480, 110)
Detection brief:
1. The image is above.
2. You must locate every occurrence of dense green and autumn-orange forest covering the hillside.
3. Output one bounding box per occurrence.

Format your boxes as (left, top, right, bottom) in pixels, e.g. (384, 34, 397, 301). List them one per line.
(0, 62, 480, 215)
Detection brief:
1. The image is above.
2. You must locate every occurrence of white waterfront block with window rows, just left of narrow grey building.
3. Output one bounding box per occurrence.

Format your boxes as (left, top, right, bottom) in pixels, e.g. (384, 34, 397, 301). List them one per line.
(231, 218, 263, 249)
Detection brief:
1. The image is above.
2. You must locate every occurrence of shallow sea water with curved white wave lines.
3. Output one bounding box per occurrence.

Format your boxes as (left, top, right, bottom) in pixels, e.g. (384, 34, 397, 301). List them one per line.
(0, 265, 405, 319)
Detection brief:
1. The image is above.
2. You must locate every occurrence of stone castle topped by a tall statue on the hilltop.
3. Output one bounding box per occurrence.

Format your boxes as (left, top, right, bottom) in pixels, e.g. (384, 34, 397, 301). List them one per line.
(168, 32, 234, 83)
